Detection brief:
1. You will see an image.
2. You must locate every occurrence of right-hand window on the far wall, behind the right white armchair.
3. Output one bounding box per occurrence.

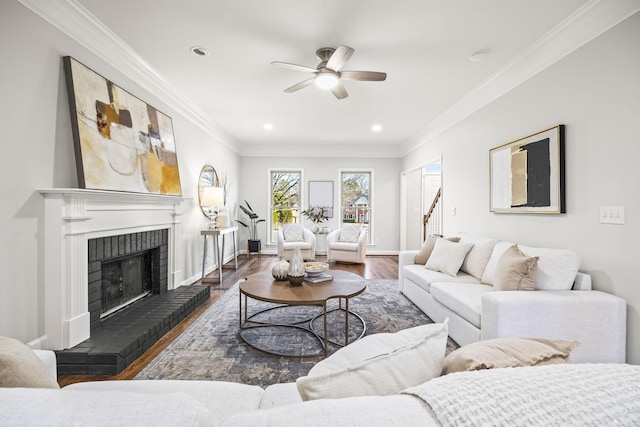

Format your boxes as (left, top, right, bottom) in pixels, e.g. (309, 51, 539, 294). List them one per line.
(340, 170, 373, 243)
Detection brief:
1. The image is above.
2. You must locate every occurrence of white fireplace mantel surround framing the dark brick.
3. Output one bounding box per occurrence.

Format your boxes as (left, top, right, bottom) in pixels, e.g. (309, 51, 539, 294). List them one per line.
(37, 188, 186, 350)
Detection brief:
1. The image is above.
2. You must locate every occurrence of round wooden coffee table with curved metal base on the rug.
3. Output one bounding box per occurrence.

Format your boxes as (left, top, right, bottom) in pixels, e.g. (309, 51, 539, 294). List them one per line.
(239, 270, 367, 357)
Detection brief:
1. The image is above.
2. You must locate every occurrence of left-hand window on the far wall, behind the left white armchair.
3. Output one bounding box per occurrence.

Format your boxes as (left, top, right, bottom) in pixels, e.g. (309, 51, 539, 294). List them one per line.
(268, 170, 302, 243)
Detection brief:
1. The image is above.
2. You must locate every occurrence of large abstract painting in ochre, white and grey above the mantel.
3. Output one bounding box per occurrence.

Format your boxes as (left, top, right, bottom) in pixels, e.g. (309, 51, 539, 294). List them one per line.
(63, 56, 182, 196)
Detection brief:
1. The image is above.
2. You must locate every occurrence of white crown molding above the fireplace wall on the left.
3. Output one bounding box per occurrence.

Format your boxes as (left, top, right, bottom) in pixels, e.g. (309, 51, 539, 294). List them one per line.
(18, 0, 238, 153)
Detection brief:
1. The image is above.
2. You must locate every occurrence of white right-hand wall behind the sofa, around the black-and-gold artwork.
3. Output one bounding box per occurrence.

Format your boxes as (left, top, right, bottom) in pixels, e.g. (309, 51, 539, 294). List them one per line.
(402, 14, 640, 364)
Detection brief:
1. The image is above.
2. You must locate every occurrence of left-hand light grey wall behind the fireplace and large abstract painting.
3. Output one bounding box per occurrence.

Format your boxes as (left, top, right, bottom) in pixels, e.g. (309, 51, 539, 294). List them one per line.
(0, 1, 238, 342)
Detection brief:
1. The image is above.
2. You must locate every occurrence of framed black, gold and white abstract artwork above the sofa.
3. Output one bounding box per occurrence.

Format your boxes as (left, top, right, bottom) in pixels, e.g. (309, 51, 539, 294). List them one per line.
(489, 125, 566, 214)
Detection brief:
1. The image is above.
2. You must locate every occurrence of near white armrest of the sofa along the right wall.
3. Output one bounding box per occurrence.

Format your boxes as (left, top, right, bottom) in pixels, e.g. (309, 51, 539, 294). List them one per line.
(481, 291, 627, 363)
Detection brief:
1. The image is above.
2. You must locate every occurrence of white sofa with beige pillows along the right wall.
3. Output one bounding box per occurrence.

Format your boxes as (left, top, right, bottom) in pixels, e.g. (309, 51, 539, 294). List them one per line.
(398, 233, 627, 362)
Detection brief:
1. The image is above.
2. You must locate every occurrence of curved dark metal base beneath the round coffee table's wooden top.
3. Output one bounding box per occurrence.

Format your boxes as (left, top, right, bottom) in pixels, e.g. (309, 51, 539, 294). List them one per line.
(240, 294, 367, 357)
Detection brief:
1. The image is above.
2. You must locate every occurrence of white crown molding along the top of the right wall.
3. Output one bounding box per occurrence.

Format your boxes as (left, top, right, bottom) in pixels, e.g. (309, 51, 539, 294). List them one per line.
(399, 0, 640, 157)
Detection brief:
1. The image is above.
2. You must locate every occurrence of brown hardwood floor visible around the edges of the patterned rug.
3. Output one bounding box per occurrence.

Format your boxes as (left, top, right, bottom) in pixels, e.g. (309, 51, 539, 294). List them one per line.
(58, 254, 398, 387)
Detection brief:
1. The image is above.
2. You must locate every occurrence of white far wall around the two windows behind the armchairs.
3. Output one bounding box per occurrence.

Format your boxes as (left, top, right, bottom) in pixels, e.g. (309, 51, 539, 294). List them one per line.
(236, 157, 400, 254)
